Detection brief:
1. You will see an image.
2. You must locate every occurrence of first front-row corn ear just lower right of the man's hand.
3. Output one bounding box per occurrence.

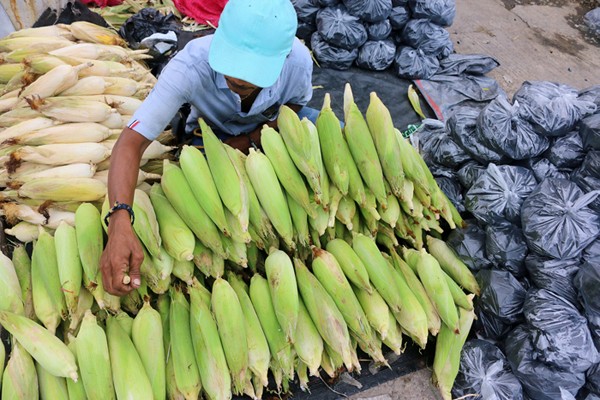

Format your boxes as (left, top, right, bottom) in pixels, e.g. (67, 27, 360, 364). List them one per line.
(131, 298, 166, 399)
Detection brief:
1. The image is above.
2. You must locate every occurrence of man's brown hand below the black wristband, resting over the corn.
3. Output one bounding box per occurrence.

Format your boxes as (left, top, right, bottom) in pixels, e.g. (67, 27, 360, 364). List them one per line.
(100, 210, 144, 296)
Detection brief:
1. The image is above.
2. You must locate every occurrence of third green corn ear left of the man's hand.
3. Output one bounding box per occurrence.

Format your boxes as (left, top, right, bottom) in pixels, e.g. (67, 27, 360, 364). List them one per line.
(31, 228, 67, 333)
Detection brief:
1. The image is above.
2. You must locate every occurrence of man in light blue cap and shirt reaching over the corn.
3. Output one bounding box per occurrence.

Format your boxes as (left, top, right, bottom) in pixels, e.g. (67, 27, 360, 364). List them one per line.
(101, 0, 312, 296)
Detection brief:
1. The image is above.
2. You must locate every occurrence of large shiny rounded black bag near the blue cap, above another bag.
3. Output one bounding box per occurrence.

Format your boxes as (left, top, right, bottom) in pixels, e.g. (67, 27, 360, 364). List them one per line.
(317, 4, 367, 50)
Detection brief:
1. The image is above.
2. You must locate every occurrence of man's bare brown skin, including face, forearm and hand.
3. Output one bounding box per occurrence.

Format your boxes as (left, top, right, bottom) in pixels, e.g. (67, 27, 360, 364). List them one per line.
(100, 77, 302, 296)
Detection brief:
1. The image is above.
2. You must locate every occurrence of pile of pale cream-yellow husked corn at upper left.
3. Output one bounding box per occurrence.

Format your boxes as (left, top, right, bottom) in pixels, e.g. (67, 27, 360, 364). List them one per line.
(0, 22, 172, 241)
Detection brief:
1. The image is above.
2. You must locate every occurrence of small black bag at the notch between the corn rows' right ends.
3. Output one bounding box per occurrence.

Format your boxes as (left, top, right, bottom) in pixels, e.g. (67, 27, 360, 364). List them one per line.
(446, 220, 492, 272)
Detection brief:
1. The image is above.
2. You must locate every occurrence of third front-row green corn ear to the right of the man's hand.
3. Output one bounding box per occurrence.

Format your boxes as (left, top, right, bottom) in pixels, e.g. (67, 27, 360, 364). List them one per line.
(188, 281, 231, 400)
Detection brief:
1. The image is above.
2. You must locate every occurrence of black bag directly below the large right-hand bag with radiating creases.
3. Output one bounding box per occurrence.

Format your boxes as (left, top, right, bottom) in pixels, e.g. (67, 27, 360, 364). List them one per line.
(525, 253, 581, 305)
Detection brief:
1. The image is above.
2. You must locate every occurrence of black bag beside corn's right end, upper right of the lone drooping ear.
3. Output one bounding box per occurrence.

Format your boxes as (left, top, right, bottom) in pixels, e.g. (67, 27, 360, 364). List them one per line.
(475, 269, 527, 324)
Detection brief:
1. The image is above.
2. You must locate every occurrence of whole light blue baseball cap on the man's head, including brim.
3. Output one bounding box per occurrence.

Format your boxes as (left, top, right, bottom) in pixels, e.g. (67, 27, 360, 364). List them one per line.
(208, 0, 298, 88)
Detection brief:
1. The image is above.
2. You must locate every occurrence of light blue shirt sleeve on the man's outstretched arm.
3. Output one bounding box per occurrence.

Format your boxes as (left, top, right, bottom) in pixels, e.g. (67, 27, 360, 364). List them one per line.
(127, 52, 192, 140)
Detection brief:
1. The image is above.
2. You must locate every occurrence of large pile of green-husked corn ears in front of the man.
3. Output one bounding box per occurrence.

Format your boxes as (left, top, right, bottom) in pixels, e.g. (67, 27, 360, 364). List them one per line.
(0, 88, 479, 399)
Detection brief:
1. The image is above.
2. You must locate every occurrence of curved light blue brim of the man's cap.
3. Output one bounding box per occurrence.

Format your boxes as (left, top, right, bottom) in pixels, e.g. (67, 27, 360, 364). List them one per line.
(208, 33, 286, 88)
